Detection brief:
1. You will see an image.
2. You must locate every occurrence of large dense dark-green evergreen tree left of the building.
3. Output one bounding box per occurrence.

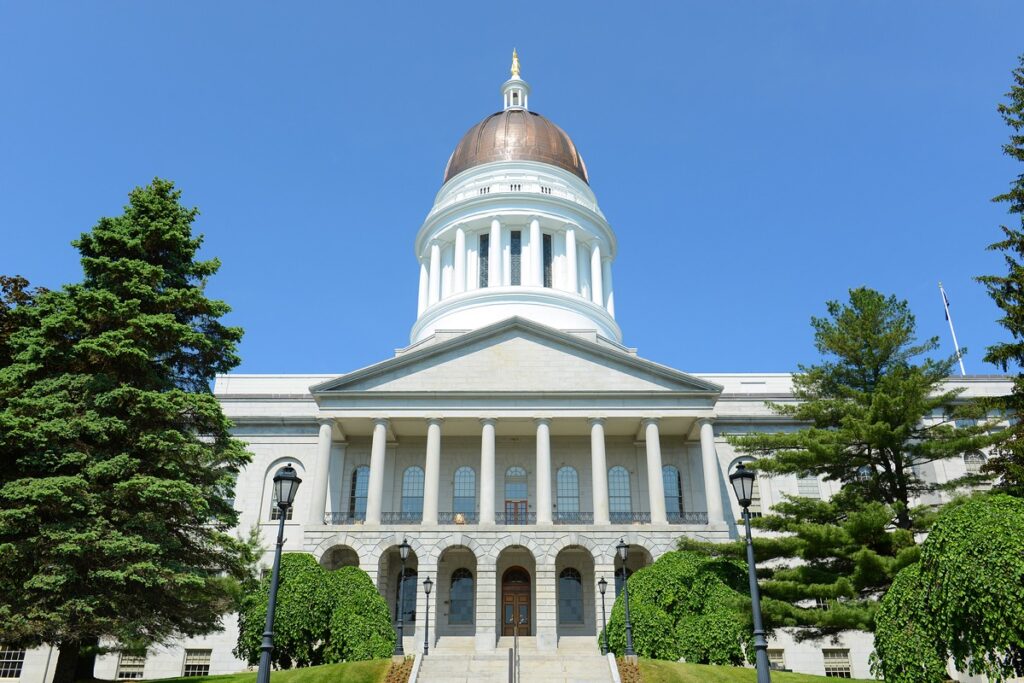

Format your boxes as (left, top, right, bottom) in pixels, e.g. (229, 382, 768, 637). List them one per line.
(0, 179, 248, 683)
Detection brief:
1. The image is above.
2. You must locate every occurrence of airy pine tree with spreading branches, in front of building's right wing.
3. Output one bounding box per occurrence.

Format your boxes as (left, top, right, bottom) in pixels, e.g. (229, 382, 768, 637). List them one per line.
(681, 288, 991, 636)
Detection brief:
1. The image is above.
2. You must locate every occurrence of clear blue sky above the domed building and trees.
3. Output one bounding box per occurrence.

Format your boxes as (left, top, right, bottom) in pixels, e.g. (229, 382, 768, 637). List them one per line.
(0, 0, 1024, 373)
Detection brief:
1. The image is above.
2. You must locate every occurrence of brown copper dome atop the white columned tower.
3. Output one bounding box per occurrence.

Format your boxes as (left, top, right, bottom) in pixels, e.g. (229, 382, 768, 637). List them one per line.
(444, 109, 590, 184)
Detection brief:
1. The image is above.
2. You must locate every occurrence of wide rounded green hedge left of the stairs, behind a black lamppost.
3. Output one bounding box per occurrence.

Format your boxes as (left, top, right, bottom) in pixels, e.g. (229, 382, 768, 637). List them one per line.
(234, 553, 394, 669)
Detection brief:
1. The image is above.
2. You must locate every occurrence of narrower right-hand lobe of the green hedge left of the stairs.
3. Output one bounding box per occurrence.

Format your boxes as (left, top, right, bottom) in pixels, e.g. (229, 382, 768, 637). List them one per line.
(325, 567, 395, 661)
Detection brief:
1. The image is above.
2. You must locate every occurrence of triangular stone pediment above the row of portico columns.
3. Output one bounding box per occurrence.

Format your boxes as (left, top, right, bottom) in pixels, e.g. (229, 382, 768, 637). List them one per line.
(311, 318, 722, 394)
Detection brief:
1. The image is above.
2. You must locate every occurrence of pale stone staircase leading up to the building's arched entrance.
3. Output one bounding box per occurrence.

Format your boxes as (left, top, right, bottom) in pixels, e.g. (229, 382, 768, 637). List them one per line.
(417, 637, 611, 683)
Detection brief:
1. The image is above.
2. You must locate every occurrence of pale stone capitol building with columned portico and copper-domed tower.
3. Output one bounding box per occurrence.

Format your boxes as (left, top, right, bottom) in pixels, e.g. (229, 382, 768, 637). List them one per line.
(16, 54, 1009, 681)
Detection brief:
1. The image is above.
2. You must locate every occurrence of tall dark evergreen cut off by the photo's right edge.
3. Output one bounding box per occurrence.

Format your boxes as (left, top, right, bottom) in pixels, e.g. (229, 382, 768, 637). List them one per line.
(978, 55, 1024, 497)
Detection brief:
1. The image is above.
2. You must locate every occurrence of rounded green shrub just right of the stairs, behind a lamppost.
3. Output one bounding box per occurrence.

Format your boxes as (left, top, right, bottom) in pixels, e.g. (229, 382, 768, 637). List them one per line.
(608, 551, 753, 665)
